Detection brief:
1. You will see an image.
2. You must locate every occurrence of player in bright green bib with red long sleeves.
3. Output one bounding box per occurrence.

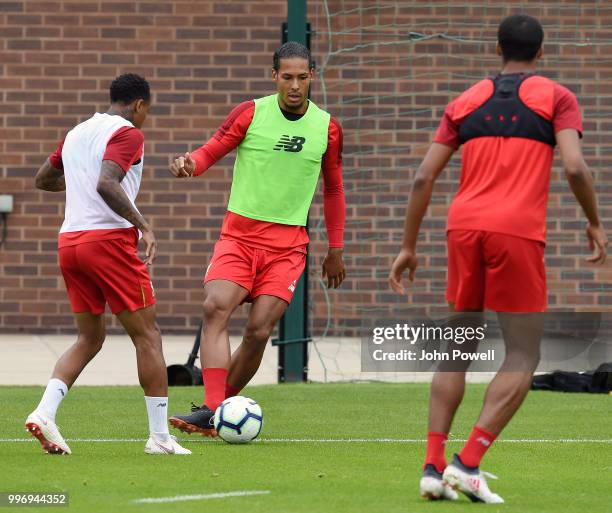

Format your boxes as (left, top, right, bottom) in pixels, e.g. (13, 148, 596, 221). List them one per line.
(170, 42, 346, 436)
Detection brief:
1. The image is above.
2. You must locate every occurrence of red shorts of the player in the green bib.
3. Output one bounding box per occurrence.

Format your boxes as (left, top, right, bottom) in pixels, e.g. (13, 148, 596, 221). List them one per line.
(204, 239, 306, 303)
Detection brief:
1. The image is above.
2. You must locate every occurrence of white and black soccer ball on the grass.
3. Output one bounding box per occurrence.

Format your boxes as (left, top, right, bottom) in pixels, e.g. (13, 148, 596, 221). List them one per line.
(215, 395, 263, 444)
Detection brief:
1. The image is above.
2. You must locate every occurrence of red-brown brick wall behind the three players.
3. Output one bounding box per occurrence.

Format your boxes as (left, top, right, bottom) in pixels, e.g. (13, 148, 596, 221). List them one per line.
(0, 0, 612, 333)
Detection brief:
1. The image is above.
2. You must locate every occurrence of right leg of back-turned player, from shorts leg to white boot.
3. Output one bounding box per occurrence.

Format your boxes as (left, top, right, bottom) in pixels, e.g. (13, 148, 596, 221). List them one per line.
(445, 233, 546, 503)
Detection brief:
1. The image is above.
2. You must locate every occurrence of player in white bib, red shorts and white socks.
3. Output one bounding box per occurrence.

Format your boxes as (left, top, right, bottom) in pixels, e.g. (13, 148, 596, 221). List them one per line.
(26, 73, 191, 454)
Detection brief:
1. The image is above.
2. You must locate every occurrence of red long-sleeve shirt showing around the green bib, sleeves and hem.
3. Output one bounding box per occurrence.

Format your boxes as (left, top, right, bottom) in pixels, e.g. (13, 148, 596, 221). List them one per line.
(191, 100, 346, 251)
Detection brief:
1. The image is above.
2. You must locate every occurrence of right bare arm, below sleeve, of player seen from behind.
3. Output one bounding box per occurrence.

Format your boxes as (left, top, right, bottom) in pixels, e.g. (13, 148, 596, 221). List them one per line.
(556, 128, 608, 263)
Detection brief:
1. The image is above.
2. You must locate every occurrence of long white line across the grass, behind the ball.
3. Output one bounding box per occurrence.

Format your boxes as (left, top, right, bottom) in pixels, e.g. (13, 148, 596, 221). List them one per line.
(0, 438, 612, 444)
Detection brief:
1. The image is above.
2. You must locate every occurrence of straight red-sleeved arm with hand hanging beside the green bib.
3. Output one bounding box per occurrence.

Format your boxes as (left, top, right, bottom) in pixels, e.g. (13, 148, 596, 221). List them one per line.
(321, 118, 346, 288)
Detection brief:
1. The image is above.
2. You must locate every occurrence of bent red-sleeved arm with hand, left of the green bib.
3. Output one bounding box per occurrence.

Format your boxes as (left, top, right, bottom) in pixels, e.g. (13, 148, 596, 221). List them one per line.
(170, 100, 255, 178)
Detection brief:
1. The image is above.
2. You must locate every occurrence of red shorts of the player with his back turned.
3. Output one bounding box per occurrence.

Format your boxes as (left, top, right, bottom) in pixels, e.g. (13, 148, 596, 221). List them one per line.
(446, 230, 547, 312)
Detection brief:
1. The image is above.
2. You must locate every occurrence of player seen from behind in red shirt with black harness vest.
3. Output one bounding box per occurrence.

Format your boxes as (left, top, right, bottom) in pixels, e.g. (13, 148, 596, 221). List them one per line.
(389, 14, 608, 503)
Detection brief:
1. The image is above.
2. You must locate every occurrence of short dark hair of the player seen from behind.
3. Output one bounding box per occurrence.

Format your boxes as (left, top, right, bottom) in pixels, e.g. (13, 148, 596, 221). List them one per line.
(497, 14, 544, 62)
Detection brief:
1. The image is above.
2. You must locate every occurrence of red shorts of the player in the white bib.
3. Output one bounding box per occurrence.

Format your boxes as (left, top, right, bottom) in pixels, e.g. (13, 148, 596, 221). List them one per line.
(59, 234, 155, 315)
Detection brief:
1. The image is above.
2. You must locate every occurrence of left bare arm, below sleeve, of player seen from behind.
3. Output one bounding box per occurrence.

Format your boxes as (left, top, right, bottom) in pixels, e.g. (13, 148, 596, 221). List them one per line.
(389, 142, 455, 294)
